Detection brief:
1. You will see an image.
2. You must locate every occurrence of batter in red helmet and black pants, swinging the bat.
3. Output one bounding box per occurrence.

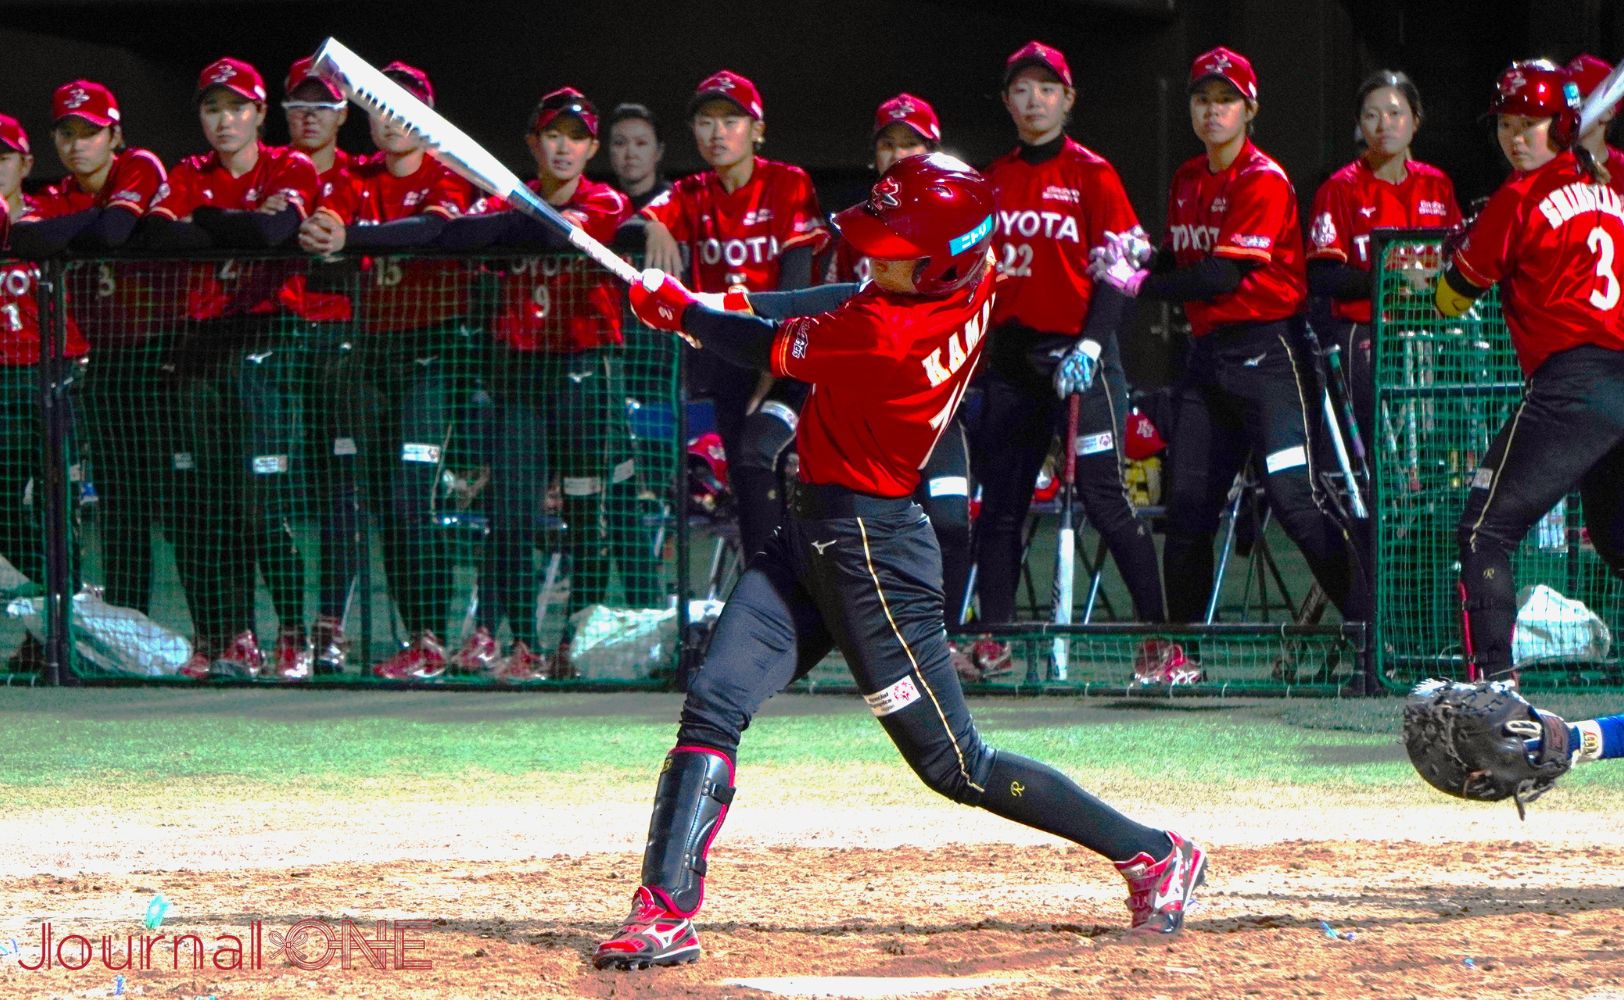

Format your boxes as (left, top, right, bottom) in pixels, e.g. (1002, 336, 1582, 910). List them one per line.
(594, 153, 1207, 969)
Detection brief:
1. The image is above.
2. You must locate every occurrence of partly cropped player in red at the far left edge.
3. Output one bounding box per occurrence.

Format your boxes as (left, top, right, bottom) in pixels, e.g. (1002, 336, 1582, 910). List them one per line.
(0, 114, 88, 670)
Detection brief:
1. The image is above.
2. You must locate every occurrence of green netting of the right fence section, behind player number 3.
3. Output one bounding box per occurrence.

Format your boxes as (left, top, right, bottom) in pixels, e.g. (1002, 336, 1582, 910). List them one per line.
(1371, 232, 1621, 685)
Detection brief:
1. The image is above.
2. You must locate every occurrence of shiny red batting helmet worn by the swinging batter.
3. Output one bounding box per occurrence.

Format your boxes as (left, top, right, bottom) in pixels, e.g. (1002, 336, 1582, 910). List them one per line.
(835, 153, 992, 295)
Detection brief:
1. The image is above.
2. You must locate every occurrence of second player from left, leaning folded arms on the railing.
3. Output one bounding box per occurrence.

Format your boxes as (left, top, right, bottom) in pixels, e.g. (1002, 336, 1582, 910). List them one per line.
(16, 80, 168, 614)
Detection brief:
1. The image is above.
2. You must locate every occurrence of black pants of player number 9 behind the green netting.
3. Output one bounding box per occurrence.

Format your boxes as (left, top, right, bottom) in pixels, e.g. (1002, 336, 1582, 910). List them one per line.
(479, 347, 663, 646)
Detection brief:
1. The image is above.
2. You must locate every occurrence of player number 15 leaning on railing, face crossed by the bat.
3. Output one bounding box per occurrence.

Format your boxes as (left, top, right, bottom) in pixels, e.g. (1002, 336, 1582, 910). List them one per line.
(299, 62, 473, 680)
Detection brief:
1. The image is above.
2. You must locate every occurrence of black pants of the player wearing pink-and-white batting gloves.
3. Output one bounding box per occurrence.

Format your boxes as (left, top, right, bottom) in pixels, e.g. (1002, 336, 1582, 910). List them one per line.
(1163, 320, 1364, 622)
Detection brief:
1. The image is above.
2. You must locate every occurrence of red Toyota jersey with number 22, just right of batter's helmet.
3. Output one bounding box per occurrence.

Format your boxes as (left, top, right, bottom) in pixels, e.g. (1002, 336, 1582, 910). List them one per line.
(984, 138, 1138, 333)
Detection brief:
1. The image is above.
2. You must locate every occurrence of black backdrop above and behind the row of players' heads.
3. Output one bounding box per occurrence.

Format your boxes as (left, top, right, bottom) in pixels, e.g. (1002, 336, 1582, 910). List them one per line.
(0, 0, 1624, 381)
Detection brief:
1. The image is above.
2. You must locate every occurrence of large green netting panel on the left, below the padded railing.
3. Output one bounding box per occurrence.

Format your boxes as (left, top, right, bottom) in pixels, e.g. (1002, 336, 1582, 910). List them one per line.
(30, 255, 685, 683)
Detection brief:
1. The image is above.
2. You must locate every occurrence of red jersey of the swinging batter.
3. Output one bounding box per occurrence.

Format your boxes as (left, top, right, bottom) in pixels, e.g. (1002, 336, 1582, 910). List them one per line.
(771, 252, 997, 497)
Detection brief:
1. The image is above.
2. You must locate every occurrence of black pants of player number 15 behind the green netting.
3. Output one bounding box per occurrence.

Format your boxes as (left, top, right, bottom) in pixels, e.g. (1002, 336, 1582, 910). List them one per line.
(335, 323, 473, 635)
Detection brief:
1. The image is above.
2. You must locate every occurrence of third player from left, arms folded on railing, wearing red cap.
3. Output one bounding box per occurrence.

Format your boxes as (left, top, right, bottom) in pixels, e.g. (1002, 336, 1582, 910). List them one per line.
(136, 58, 317, 679)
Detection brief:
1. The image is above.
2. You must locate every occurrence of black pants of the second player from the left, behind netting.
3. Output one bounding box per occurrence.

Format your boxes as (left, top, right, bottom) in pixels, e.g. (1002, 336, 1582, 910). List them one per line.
(83, 339, 172, 614)
